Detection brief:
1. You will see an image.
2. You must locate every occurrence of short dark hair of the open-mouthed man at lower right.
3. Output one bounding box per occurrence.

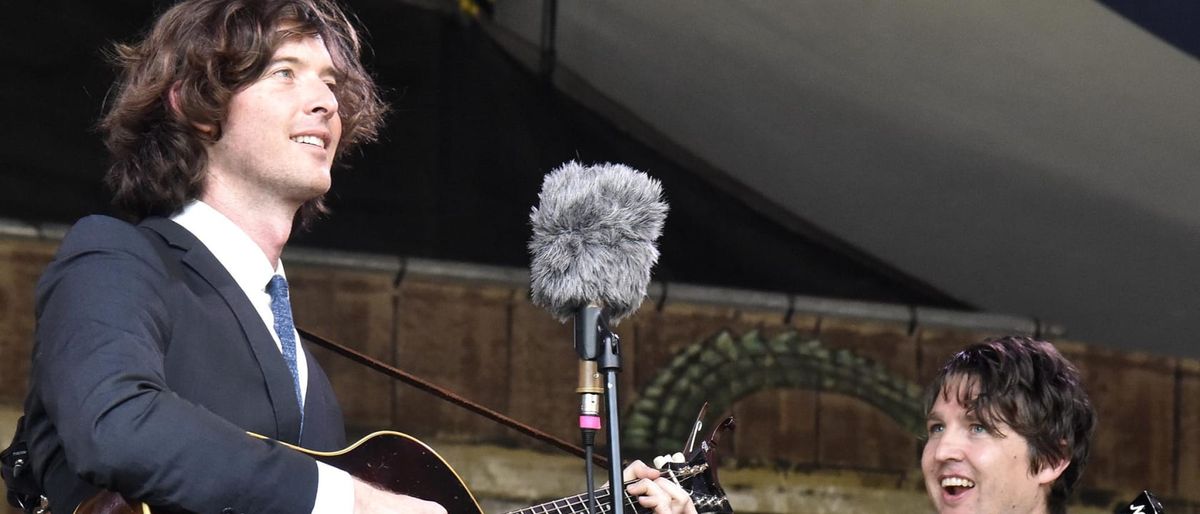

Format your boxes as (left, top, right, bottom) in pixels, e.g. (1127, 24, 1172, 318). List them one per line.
(925, 336, 1096, 514)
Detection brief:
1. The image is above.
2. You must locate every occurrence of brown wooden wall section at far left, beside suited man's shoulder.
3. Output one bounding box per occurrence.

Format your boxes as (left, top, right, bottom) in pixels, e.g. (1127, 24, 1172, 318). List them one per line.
(0, 240, 58, 403)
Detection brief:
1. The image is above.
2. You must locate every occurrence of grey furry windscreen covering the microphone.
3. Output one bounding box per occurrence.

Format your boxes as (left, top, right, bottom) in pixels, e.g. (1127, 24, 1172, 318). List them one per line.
(529, 161, 667, 324)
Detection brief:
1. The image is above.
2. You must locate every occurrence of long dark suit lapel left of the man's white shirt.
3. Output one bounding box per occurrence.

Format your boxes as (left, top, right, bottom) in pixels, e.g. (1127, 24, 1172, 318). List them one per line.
(142, 217, 304, 443)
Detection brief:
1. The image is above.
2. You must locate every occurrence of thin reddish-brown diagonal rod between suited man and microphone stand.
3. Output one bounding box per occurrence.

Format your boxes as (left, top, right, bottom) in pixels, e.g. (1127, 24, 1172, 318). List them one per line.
(296, 327, 608, 468)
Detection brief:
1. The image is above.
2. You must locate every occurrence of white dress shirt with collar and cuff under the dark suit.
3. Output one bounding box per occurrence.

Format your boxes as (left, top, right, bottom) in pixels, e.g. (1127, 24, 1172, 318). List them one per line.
(170, 199, 354, 514)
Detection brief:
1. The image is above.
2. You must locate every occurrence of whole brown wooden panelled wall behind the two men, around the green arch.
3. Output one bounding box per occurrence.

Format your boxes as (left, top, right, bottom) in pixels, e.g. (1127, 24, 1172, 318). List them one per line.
(0, 239, 1200, 504)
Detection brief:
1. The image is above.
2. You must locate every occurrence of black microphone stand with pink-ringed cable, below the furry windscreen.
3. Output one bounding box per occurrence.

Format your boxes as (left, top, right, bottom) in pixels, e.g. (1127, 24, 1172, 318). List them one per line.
(575, 304, 625, 514)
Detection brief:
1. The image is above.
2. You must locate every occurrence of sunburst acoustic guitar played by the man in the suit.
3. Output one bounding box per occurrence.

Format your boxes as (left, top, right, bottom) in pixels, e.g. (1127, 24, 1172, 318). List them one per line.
(76, 418, 733, 514)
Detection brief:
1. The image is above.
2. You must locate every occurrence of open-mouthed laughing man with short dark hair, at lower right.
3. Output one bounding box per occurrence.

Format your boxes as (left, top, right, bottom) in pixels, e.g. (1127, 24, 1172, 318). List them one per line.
(920, 337, 1096, 514)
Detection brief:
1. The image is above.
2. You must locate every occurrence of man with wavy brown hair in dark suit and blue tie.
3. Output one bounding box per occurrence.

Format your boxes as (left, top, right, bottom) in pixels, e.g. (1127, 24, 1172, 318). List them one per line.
(18, 0, 695, 514)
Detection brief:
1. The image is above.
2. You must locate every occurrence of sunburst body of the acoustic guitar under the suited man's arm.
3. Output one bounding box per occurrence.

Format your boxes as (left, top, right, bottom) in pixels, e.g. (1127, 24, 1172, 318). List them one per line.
(76, 431, 484, 514)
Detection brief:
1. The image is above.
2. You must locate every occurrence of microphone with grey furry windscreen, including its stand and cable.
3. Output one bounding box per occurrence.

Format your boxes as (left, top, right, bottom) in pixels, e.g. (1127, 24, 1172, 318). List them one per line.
(529, 161, 667, 514)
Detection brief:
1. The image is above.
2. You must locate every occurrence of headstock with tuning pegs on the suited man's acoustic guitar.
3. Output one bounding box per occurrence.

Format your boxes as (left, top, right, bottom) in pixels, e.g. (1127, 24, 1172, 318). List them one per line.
(662, 412, 734, 514)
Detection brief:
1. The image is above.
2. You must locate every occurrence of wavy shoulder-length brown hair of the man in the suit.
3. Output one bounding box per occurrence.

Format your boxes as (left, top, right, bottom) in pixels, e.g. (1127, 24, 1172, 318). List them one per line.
(100, 0, 386, 225)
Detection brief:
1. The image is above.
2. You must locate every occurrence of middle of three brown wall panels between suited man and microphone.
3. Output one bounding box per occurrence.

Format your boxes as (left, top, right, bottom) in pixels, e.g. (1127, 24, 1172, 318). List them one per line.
(394, 280, 512, 441)
